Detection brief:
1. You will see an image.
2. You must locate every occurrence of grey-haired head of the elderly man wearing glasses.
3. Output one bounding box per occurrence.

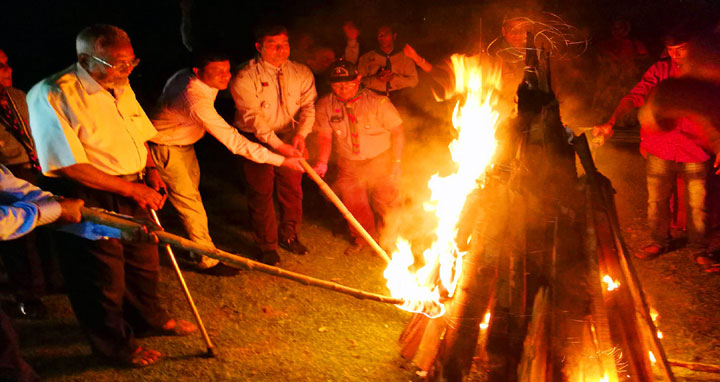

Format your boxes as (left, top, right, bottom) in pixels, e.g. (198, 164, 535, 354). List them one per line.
(75, 24, 140, 89)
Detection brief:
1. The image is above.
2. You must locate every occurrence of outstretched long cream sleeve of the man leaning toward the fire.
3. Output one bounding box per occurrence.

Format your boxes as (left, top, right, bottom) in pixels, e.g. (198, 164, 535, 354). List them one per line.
(189, 93, 285, 166)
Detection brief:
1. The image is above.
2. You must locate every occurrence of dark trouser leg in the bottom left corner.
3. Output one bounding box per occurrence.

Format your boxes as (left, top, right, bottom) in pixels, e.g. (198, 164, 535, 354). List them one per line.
(0, 310, 39, 382)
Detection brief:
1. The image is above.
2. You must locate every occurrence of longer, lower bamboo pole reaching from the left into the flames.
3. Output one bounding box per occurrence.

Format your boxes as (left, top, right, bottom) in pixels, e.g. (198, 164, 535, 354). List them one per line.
(82, 207, 404, 308)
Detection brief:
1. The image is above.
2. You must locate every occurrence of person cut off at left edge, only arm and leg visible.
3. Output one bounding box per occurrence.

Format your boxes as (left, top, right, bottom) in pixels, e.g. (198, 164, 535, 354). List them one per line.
(0, 165, 83, 382)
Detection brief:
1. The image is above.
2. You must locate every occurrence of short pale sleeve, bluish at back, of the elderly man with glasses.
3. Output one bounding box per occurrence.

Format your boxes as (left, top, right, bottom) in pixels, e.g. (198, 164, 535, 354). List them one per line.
(27, 85, 89, 174)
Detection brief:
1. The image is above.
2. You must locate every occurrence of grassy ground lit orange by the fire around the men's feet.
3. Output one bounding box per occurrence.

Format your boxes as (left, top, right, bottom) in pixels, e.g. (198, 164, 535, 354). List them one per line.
(5, 132, 720, 382)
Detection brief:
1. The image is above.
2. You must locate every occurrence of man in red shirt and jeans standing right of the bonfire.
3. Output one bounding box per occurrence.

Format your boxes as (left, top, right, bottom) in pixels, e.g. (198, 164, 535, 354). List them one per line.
(593, 26, 710, 265)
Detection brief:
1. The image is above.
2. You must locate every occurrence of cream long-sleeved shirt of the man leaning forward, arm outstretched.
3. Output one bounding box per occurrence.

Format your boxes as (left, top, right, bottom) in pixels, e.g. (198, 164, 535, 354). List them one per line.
(151, 69, 285, 166)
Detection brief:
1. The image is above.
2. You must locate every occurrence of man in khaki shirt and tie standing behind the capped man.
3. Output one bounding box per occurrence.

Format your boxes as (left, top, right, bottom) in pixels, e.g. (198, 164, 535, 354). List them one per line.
(346, 25, 416, 98)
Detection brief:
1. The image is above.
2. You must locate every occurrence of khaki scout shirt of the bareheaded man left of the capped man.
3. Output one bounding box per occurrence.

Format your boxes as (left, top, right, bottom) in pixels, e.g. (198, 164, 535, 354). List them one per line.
(230, 58, 317, 148)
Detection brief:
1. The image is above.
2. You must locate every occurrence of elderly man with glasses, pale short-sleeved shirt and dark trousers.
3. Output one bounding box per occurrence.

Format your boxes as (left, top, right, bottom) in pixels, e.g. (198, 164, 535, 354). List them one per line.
(28, 25, 196, 367)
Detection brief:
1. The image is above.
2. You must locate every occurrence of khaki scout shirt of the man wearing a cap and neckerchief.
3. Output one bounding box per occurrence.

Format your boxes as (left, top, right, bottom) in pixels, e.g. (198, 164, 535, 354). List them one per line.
(315, 90, 402, 160)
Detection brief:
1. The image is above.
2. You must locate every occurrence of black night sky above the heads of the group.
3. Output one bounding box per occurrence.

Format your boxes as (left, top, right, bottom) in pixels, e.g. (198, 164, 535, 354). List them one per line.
(0, 0, 718, 107)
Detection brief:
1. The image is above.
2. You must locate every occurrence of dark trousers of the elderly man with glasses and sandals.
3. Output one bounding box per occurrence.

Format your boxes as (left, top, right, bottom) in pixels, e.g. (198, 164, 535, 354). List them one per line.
(40, 178, 169, 358)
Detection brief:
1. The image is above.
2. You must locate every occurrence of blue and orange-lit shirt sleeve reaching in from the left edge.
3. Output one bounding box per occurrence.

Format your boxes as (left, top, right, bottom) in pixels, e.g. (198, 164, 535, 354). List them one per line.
(0, 166, 62, 240)
